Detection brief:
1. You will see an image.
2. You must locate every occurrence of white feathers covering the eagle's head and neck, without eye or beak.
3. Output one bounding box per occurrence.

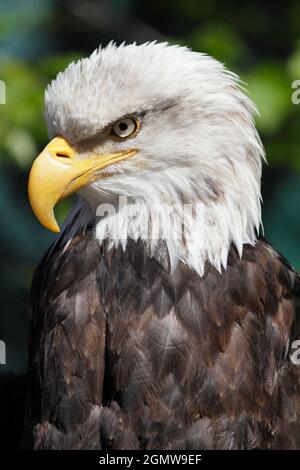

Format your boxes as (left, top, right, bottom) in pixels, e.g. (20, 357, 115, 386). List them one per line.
(46, 43, 264, 275)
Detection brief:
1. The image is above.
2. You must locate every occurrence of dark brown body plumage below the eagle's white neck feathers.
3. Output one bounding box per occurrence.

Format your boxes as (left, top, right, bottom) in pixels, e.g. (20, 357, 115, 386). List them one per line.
(20, 207, 300, 449)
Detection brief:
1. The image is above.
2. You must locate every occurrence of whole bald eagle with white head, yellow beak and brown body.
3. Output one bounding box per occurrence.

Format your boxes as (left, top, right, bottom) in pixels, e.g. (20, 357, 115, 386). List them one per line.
(20, 43, 300, 449)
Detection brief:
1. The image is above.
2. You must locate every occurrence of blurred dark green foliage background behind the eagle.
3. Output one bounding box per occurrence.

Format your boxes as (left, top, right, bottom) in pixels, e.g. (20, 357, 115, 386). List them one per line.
(0, 0, 300, 372)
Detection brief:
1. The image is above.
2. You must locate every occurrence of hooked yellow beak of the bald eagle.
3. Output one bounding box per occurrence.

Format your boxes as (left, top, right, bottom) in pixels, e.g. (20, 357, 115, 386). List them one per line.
(28, 137, 136, 232)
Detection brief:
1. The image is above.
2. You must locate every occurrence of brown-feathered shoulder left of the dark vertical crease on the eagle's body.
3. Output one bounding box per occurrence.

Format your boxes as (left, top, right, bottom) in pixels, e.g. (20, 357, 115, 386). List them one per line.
(25, 205, 105, 449)
